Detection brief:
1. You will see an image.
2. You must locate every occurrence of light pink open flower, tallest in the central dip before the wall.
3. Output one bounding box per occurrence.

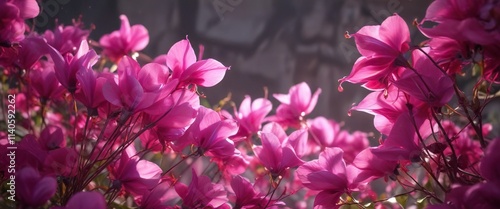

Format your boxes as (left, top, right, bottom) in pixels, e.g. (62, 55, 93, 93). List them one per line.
(268, 82, 321, 128)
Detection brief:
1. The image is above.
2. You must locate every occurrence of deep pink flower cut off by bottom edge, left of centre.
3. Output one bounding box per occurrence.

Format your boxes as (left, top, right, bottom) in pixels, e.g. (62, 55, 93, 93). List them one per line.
(175, 170, 228, 208)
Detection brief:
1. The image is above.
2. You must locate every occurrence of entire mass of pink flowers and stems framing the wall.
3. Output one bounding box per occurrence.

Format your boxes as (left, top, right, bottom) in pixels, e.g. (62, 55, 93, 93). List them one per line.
(0, 0, 500, 209)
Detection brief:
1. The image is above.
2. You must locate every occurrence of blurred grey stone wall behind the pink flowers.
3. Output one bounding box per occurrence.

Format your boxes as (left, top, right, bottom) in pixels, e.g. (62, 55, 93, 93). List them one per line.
(35, 0, 431, 134)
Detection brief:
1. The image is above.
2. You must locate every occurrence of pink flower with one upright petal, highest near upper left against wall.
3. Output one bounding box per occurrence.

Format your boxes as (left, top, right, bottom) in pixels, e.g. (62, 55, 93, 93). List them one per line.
(99, 15, 149, 63)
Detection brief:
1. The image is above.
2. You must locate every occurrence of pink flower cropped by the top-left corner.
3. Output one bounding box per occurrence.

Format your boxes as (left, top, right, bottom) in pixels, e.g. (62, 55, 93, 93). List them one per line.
(0, 0, 40, 44)
